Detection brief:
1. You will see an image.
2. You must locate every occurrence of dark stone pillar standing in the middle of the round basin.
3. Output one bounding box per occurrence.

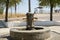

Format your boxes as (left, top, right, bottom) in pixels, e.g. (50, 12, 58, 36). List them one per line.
(26, 13, 34, 30)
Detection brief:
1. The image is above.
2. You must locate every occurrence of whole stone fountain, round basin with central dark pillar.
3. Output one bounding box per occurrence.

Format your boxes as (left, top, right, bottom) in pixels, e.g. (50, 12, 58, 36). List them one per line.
(10, 13, 50, 40)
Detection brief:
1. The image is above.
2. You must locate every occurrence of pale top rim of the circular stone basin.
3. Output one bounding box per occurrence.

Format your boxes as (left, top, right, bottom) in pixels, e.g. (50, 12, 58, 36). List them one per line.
(10, 27, 50, 33)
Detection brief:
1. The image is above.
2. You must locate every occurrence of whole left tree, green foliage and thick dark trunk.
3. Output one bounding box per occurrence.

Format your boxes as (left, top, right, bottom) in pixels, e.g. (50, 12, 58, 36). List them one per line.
(0, 0, 21, 22)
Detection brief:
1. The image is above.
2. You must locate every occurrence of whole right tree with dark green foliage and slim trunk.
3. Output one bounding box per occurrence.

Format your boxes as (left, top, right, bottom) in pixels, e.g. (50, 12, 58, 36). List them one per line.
(39, 0, 60, 21)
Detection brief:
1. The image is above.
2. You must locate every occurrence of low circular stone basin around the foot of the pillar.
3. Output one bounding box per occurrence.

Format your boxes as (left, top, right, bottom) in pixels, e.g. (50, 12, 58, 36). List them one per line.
(10, 27, 50, 40)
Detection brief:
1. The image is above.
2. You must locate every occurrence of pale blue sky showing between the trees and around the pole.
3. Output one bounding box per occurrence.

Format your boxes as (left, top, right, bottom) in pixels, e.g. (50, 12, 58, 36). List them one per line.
(4, 0, 60, 13)
